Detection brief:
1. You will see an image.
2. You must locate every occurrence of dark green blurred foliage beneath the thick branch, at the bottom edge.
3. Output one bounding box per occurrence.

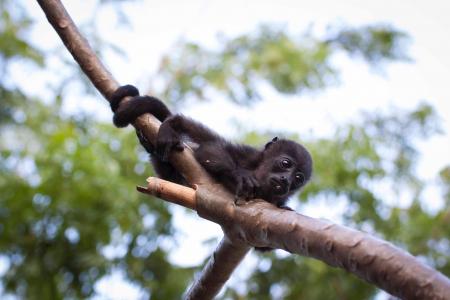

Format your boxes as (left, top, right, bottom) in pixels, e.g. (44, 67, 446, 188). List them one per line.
(241, 255, 376, 300)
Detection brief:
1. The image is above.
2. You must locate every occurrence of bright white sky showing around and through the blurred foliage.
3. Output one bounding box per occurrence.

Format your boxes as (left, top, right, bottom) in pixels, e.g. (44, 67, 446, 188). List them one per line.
(12, 0, 450, 299)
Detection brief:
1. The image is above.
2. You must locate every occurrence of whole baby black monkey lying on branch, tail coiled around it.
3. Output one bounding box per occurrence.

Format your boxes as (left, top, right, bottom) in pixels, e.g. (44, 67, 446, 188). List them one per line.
(111, 85, 312, 207)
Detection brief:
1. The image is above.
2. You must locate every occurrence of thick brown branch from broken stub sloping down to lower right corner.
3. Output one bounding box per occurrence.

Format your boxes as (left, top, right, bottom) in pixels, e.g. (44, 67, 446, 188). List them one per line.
(146, 178, 450, 300)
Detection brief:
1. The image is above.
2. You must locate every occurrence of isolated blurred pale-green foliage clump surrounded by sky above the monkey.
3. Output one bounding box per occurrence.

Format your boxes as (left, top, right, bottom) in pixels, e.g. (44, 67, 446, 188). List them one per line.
(160, 25, 408, 104)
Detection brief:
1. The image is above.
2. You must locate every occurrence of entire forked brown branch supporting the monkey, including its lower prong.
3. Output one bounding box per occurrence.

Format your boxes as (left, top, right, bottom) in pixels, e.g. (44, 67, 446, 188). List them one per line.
(37, 0, 450, 299)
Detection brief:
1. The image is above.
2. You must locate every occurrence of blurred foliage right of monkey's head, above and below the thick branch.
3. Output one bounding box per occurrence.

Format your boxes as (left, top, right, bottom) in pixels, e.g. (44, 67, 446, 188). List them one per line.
(237, 104, 450, 299)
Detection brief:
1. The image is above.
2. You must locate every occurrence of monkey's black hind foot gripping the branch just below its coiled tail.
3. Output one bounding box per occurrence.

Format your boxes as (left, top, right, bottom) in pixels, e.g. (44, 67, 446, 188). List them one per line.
(156, 119, 184, 161)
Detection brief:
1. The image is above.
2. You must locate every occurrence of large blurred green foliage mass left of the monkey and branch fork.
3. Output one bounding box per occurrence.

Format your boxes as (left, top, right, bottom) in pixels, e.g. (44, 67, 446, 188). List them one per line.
(0, 95, 191, 299)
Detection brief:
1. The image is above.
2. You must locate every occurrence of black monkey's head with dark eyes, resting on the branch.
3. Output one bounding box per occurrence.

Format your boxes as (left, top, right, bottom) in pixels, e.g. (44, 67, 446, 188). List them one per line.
(254, 138, 312, 205)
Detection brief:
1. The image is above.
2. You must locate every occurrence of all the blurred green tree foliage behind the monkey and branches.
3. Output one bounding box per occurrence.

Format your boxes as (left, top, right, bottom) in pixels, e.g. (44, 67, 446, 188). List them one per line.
(0, 0, 450, 299)
